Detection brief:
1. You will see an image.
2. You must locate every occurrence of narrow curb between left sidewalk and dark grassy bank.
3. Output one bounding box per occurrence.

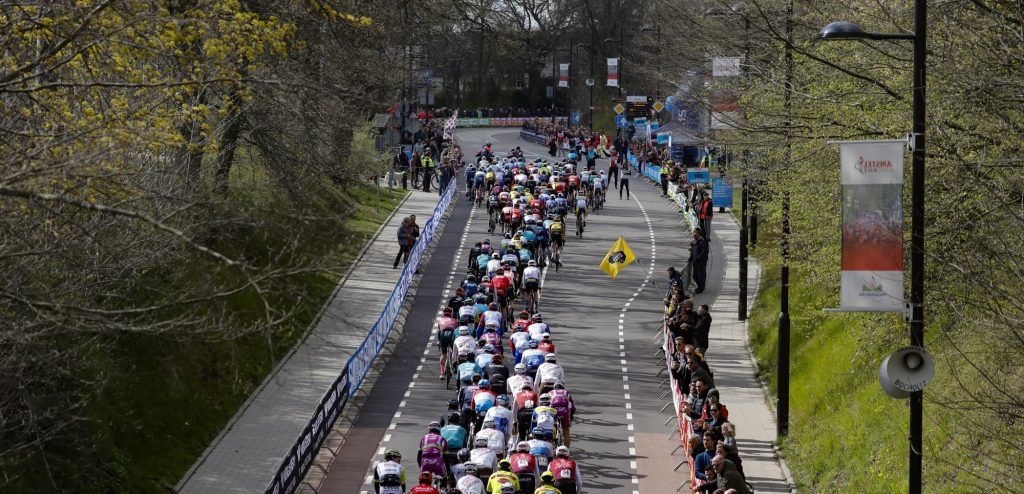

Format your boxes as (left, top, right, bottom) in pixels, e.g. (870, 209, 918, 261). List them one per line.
(174, 192, 412, 492)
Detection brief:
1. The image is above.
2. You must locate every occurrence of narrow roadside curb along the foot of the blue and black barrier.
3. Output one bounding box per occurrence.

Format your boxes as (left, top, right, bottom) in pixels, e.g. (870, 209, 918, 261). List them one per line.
(295, 187, 461, 494)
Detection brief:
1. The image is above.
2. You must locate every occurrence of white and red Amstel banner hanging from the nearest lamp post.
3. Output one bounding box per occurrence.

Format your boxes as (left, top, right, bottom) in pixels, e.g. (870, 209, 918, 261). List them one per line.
(839, 140, 906, 312)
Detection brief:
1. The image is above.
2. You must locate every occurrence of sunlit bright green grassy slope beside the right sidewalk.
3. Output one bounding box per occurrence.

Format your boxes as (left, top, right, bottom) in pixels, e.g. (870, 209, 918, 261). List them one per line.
(750, 222, 964, 494)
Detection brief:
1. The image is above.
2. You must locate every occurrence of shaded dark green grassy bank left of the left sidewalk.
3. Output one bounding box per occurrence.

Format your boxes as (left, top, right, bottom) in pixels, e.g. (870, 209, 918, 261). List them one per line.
(0, 179, 404, 493)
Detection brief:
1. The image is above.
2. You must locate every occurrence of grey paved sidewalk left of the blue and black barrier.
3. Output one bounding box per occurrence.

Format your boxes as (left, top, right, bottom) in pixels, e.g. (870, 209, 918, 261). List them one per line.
(176, 192, 438, 494)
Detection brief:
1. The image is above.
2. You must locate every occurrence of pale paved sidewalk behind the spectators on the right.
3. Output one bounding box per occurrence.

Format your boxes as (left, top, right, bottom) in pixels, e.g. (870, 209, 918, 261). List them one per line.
(697, 213, 791, 493)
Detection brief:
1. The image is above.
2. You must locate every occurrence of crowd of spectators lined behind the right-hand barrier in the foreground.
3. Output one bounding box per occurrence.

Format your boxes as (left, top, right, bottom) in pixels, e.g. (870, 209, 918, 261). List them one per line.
(665, 267, 751, 494)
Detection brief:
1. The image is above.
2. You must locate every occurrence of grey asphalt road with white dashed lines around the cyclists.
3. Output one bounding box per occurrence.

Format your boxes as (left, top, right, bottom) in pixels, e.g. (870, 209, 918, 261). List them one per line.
(321, 129, 723, 494)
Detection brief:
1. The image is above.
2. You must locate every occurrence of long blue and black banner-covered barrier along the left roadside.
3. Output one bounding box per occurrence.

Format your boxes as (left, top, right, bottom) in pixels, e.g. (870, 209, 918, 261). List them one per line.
(264, 155, 457, 494)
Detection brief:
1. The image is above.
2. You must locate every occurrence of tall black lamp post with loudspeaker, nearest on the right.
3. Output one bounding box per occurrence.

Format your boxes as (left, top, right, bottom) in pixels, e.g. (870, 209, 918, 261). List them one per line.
(818, 0, 928, 494)
